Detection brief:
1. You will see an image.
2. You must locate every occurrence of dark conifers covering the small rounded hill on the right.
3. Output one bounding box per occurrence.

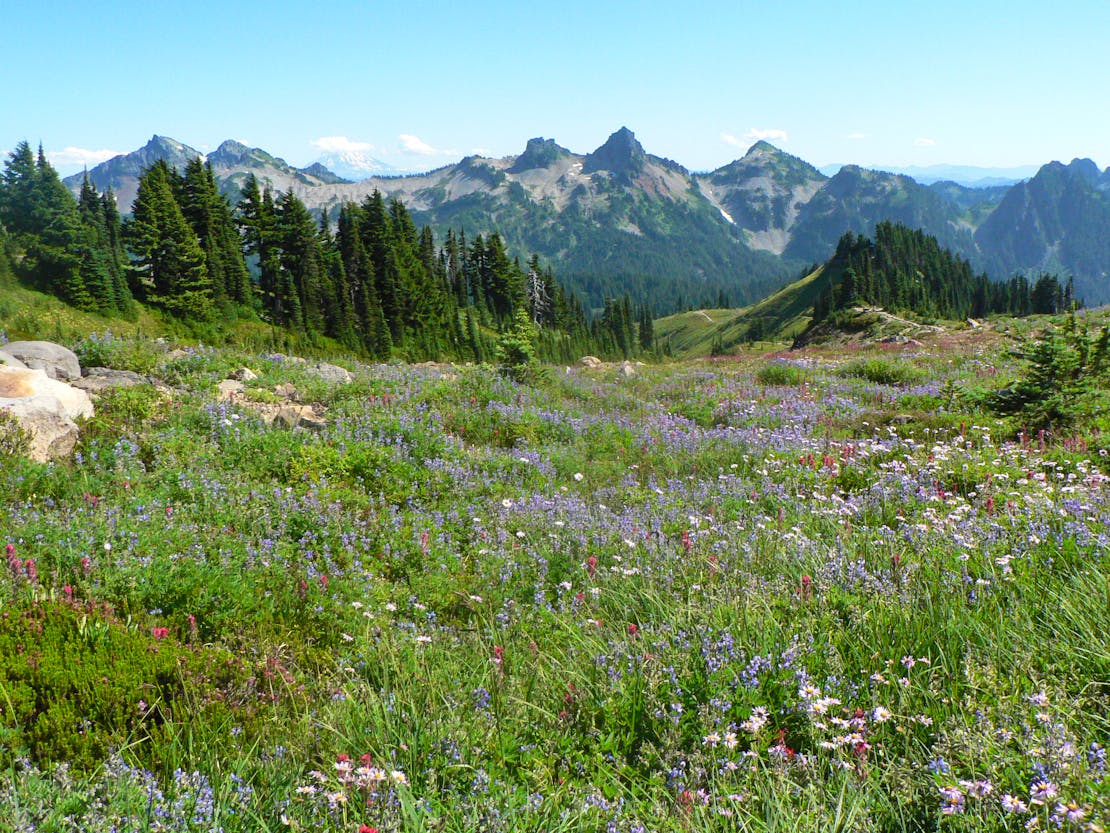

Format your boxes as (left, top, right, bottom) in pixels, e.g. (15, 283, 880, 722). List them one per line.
(813, 222, 1076, 324)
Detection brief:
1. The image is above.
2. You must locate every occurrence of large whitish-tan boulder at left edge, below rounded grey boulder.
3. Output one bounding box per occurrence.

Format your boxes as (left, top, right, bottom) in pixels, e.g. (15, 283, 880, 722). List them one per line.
(0, 365, 92, 462)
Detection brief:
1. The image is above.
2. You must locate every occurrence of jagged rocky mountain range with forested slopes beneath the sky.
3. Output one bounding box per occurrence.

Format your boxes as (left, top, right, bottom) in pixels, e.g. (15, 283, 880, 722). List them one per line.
(65, 128, 1110, 311)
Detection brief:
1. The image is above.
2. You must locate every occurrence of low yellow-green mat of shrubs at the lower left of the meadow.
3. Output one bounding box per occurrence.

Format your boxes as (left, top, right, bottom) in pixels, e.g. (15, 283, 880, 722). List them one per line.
(0, 599, 255, 771)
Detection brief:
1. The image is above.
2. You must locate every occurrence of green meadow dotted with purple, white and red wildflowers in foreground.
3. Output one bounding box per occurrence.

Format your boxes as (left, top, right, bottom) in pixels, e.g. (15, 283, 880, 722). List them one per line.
(0, 328, 1110, 833)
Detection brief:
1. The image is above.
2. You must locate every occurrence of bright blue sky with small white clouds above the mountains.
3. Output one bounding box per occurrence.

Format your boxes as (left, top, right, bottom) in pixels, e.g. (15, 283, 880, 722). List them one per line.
(0, 0, 1110, 173)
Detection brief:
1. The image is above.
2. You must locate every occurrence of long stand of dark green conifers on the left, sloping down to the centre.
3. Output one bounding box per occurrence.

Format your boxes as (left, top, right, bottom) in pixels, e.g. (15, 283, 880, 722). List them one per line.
(0, 142, 653, 362)
